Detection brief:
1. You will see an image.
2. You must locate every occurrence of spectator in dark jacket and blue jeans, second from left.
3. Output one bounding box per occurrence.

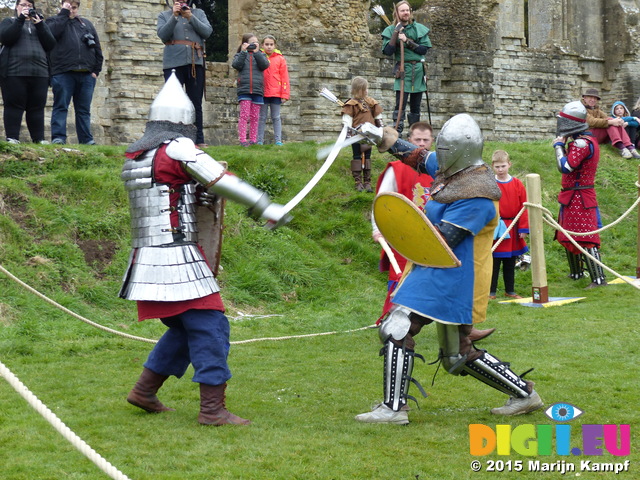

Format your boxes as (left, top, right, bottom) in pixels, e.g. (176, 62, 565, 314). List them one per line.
(46, 0, 103, 145)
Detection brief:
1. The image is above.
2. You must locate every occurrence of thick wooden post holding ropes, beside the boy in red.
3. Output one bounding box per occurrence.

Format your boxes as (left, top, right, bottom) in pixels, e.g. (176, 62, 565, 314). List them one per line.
(526, 173, 549, 303)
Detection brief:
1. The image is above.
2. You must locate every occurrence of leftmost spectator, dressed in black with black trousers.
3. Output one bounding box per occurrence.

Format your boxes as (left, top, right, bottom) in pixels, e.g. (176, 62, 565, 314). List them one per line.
(0, 0, 56, 143)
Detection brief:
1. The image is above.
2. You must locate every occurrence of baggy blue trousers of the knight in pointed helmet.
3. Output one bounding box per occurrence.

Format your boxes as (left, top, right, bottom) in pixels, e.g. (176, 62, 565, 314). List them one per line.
(144, 310, 231, 385)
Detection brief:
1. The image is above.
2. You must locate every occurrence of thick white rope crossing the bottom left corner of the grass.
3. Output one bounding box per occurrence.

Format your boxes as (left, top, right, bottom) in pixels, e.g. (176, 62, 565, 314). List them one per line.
(0, 362, 129, 480)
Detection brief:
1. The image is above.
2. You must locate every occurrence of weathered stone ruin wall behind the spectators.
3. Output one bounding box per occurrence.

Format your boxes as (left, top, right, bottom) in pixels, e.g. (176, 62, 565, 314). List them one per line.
(3, 0, 640, 144)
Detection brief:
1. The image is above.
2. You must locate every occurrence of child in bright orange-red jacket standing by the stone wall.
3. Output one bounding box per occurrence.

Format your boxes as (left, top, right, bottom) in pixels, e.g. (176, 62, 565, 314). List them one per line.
(258, 35, 289, 145)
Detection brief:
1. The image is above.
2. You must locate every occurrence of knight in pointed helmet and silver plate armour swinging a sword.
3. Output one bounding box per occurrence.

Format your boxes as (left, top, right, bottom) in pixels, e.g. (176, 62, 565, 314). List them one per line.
(120, 71, 290, 425)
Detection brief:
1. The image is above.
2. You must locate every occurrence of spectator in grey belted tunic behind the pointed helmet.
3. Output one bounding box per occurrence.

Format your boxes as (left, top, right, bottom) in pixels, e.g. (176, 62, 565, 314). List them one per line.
(157, 0, 213, 148)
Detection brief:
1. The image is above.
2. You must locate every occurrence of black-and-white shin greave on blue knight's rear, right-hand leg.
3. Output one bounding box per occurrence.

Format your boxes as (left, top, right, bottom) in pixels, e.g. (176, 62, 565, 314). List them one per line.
(462, 351, 531, 398)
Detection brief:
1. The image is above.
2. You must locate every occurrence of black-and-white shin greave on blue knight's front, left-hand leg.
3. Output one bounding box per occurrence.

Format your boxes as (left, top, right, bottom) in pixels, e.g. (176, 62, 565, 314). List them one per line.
(380, 339, 427, 412)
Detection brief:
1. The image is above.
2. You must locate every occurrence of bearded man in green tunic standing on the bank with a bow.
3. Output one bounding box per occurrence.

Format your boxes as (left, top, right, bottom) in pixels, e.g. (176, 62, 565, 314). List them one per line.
(382, 1, 431, 133)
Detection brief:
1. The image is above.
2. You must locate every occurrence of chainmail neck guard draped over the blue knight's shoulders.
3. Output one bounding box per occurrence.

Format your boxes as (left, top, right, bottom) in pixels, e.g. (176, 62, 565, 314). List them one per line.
(431, 164, 502, 203)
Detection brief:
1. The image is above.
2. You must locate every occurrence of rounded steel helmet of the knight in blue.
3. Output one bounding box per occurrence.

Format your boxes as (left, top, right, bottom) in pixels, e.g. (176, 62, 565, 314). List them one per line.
(436, 113, 484, 178)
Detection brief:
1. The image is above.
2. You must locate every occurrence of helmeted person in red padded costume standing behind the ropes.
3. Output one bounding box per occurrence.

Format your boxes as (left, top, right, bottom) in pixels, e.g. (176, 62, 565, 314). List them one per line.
(553, 101, 607, 288)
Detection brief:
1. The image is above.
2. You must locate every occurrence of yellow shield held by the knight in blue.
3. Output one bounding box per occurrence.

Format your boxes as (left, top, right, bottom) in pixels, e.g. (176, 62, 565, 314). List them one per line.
(373, 192, 461, 268)
